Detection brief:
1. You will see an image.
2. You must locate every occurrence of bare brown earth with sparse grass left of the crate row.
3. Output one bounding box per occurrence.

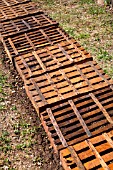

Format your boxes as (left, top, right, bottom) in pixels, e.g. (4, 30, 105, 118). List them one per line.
(0, 46, 62, 170)
